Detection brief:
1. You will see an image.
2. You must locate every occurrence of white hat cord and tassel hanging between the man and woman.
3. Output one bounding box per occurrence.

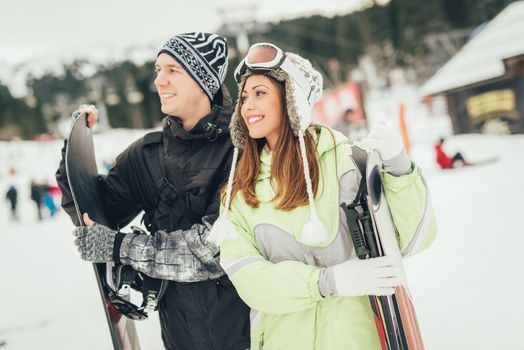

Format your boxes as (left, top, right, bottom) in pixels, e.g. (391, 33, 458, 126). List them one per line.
(207, 147, 243, 246)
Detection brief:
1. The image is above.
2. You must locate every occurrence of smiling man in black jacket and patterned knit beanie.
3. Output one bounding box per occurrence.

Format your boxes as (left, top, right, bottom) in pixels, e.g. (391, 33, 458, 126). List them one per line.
(57, 33, 249, 350)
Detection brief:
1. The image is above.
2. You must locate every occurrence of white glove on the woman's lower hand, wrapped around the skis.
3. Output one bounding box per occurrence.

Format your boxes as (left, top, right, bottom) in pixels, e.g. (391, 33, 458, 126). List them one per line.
(328, 256, 406, 296)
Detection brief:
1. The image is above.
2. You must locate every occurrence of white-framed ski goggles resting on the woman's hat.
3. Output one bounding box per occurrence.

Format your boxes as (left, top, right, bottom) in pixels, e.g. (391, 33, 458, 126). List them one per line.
(234, 43, 314, 106)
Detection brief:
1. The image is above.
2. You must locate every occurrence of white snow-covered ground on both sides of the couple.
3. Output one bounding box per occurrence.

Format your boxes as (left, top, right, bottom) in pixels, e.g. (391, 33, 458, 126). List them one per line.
(0, 116, 524, 350)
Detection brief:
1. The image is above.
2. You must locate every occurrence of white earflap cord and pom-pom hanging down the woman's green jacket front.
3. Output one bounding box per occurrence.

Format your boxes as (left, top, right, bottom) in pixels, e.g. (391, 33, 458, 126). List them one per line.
(298, 130, 328, 245)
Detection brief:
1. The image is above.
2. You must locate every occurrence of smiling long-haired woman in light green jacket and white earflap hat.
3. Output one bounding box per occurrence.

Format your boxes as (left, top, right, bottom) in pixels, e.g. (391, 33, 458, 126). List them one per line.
(209, 43, 435, 350)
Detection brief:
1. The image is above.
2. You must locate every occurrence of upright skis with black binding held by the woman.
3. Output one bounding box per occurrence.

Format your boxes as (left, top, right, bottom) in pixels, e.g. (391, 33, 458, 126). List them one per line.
(343, 146, 424, 350)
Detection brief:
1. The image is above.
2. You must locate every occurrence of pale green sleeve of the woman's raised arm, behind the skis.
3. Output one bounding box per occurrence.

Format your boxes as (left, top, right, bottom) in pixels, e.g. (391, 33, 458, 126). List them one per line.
(383, 163, 437, 256)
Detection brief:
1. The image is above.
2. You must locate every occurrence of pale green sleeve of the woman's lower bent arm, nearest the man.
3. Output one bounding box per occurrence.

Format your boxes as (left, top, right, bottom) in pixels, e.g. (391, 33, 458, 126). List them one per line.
(220, 200, 322, 314)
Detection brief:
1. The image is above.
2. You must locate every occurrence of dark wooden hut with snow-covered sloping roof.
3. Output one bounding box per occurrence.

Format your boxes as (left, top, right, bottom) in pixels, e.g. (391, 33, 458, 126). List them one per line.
(422, 1, 524, 134)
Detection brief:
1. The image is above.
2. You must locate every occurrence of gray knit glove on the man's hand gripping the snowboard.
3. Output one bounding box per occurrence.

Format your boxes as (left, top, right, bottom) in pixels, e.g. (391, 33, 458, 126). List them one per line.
(73, 223, 117, 263)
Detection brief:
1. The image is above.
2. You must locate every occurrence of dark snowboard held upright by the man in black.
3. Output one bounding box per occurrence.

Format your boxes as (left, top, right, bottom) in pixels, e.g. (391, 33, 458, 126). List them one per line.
(65, 113, 140, 350)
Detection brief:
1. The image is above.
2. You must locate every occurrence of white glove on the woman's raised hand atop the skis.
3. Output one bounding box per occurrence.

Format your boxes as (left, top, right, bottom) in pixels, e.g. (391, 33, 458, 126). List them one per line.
(361, 124, 404, 162)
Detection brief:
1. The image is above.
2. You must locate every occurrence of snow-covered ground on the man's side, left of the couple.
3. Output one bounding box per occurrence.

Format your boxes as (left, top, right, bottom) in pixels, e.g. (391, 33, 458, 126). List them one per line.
(0, 130, 163, 350)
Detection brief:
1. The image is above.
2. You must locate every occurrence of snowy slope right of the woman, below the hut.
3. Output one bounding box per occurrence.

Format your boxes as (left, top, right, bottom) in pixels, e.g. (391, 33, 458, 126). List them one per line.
(406, 135, 524, 350)
